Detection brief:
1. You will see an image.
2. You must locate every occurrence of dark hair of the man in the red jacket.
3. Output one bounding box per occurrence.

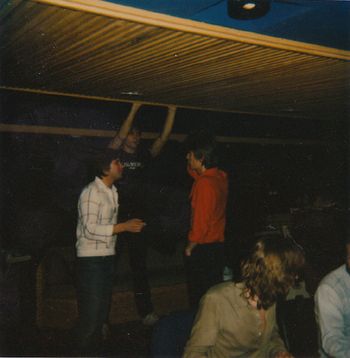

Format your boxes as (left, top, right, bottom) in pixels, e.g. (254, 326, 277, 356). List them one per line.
(186, 130, 219, 169)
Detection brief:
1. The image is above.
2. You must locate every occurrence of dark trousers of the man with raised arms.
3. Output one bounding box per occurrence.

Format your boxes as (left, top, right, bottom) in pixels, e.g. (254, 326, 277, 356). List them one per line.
(117, 232, 153, 317)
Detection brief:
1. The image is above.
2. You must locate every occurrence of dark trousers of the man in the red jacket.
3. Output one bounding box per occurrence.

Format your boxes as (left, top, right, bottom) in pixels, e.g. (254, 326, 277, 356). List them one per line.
(185, 243, 225, 308)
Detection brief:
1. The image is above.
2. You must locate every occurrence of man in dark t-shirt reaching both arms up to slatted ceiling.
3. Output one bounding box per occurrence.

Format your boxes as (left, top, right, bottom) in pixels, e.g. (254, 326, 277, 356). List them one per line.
(109, 103, 176, 325)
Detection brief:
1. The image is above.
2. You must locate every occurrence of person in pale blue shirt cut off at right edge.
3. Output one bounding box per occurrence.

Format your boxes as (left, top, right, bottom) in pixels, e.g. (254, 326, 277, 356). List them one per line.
(315, 237, 350, 358)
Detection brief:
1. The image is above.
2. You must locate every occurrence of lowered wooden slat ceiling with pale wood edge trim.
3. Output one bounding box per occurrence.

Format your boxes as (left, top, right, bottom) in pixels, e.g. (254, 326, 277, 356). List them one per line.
(0, 0, 350, 119)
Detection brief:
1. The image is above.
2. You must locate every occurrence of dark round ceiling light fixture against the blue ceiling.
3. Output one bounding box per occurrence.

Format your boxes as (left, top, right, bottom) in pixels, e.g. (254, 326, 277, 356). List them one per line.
(227, 0, 271, 20)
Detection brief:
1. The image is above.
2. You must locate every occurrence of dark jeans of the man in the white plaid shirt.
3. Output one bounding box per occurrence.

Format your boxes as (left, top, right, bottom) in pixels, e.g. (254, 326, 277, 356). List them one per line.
(77, 256, 115, 354)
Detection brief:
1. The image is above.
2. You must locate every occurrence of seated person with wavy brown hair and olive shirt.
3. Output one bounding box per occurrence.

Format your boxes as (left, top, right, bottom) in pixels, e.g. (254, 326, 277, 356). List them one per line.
(184, 234, 305, 358)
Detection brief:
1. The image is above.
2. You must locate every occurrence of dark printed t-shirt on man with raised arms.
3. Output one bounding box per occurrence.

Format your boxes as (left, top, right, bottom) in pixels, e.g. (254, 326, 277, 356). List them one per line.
(117, 148, 152, 219)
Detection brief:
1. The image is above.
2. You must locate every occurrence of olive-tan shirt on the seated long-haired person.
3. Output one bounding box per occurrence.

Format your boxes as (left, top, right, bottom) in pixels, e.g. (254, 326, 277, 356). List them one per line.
(184, 282, 286, 358)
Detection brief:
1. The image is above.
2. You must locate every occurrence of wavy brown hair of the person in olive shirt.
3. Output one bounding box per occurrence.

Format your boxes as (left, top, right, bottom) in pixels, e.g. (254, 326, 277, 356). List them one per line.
(241, 234, 305, 309)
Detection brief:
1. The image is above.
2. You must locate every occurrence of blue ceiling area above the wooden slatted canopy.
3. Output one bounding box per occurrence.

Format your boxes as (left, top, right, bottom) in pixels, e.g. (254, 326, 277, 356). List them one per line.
(105, 0, 350, 50)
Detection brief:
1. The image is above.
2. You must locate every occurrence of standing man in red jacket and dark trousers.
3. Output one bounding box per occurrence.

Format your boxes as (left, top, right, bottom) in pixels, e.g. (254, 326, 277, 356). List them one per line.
(185, 135, 228, 307)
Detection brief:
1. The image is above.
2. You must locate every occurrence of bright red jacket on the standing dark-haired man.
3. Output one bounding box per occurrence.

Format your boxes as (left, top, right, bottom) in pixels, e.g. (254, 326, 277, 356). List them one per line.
(188, 168, 228, 244)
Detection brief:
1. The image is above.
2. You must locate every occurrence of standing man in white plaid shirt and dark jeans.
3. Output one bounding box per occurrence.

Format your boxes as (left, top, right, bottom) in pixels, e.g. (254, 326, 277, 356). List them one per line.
(76, 150, 145, 354)
